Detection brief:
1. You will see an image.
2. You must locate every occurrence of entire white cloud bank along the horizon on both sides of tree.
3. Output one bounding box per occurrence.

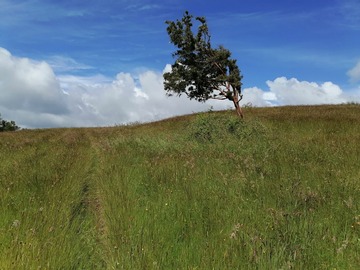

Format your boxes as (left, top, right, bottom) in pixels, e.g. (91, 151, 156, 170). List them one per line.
(0, 48, 358, 128)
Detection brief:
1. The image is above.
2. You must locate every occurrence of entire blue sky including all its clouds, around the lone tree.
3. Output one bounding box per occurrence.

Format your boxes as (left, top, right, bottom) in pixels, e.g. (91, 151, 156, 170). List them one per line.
(0, 0, 360, 127)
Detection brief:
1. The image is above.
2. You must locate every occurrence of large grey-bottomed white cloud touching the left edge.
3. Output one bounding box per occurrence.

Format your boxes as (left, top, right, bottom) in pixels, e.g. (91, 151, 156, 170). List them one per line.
(0, 48, 68, 114)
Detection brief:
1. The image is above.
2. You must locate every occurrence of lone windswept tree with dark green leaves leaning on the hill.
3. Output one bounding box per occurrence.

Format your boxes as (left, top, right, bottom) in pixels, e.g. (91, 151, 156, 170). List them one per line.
(164, 11, 243, 118)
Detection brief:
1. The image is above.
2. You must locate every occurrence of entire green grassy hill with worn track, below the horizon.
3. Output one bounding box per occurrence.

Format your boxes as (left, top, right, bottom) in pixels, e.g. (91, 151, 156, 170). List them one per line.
(0, 105, 360, 269)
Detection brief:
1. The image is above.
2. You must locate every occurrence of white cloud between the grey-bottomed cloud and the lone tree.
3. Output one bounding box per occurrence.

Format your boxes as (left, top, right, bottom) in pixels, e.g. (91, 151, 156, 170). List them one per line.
(60, 71, 229, 126)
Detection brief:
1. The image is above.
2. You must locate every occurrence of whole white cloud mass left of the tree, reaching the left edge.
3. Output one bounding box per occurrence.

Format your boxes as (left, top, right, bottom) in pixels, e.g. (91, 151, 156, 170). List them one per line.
(0, 49, 224, 128)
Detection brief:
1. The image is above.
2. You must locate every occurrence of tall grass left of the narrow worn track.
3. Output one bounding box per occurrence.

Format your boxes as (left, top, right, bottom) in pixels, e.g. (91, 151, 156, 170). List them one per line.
(0, 130, 105, 269)
